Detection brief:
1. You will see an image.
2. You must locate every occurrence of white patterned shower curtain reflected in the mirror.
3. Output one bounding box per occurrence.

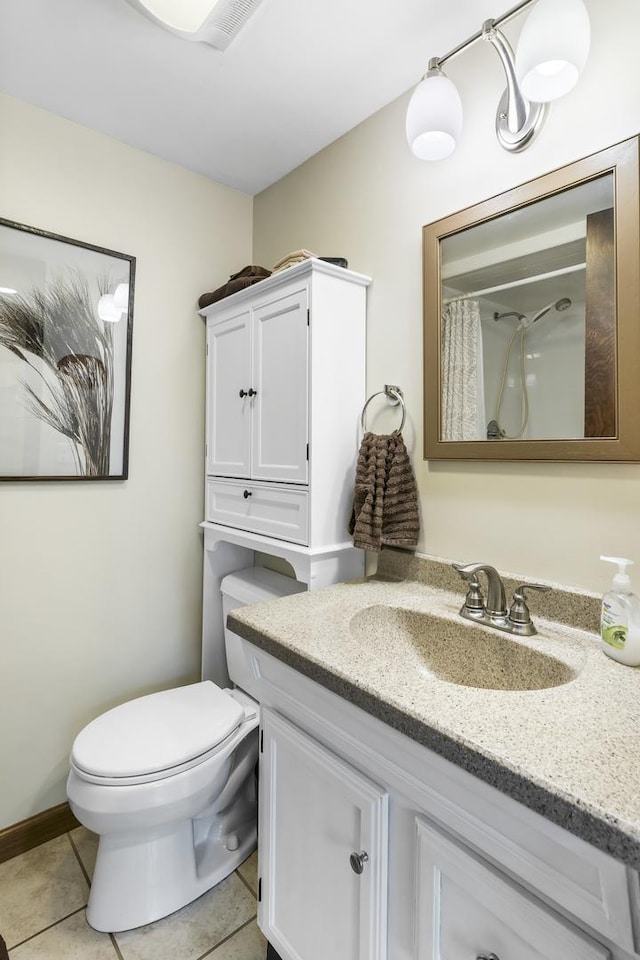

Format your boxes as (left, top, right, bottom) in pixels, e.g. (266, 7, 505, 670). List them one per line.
(442, 300, 487, 440)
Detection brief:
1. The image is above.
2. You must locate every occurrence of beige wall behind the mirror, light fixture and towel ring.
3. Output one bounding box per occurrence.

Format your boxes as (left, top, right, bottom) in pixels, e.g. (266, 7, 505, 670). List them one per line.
(254, 0, 640, 593)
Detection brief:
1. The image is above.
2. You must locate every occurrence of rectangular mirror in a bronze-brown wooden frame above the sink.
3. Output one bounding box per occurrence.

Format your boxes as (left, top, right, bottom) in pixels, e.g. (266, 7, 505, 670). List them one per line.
(423, 137, 640, 461)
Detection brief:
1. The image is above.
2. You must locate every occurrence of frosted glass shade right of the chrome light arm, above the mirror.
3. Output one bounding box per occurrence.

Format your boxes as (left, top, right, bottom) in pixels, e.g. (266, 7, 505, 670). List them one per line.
(516, 0, 591, 103)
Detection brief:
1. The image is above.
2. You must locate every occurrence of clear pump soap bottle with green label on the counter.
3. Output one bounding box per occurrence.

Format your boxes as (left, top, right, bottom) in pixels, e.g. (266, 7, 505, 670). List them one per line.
(600, 557, 640, 667)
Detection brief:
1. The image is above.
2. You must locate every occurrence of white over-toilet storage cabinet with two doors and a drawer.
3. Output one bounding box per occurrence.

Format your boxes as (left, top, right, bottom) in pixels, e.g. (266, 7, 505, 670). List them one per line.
(202, 260, 369, 548)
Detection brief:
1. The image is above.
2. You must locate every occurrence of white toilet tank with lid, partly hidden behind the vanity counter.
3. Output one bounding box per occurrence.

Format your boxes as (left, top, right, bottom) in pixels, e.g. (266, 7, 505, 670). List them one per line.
(220, 567, 307, 689)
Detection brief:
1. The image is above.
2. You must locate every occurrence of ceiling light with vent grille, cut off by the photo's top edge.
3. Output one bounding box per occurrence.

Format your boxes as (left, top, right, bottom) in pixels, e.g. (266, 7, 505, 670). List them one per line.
(128, 0, 262, 50)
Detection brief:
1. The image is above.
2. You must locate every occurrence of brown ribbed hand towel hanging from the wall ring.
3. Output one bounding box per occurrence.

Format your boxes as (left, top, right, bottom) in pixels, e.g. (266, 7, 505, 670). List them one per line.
(349, 430, 420, 550)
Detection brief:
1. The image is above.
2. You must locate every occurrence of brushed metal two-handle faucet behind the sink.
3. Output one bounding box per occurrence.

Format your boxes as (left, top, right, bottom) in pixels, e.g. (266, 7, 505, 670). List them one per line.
(452, 563, 550, 637)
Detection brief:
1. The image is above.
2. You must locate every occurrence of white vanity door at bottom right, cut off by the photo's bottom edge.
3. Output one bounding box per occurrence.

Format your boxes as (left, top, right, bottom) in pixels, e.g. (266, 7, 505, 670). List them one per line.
(415, 818, 610, 960)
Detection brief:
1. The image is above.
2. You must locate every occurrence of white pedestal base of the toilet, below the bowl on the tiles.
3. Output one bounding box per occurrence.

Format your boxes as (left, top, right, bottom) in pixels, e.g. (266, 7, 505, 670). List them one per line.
(87, 819, 257, 933)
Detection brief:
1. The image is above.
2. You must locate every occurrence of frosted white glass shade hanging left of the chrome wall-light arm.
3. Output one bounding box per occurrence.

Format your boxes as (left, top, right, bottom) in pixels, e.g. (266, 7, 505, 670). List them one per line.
(407, 69, 462, 160)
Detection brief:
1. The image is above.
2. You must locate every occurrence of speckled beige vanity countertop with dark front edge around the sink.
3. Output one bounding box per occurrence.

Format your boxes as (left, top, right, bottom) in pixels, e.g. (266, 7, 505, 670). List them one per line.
(229, 548, 640, 868)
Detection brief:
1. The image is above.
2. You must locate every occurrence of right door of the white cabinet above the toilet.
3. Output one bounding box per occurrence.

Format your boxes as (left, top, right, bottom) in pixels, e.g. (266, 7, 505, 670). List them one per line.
(252, 286, 309, 483)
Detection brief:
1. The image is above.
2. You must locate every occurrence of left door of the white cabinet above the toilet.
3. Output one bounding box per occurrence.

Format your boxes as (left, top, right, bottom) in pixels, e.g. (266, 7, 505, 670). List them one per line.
(207, 309, 253, 477)
